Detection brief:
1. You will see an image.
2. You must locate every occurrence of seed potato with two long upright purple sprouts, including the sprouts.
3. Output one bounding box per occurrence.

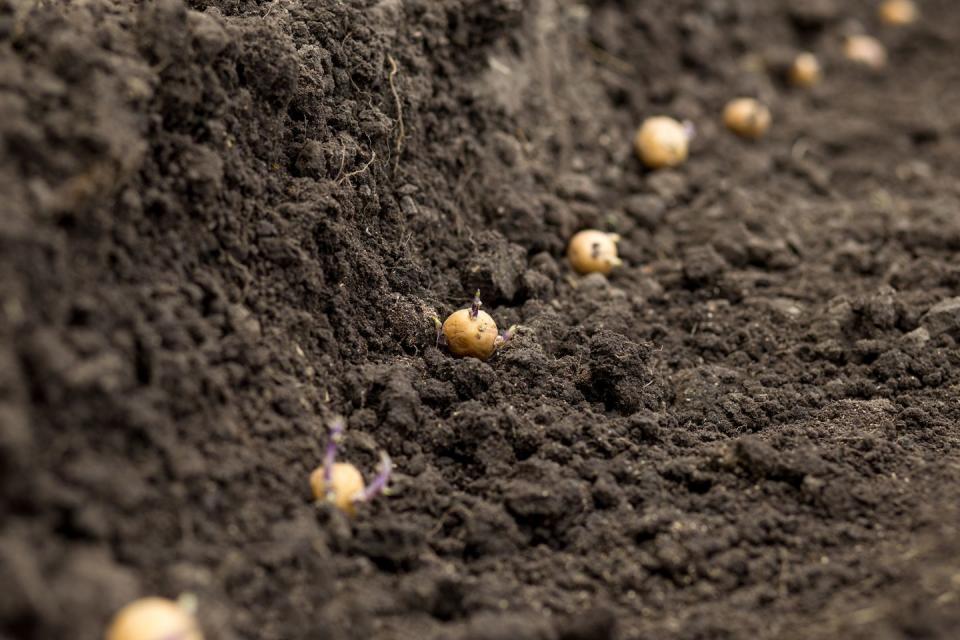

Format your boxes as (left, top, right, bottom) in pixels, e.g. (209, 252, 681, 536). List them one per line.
(310, 417, 393, 516)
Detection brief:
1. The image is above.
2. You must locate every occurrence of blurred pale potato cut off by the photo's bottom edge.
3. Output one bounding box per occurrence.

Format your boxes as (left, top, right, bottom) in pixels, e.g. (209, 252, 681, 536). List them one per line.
(106, 597, 203, 640)
